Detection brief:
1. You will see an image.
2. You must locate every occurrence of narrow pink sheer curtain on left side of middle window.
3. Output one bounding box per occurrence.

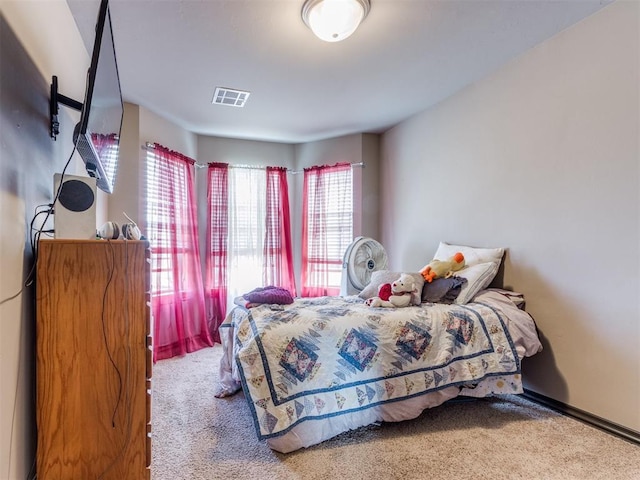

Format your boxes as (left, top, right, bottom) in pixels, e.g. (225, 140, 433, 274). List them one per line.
(205, 163, 229, 342)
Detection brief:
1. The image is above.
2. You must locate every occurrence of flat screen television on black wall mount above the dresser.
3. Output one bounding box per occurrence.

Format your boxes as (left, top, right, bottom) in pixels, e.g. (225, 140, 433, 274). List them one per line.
(51, 0, 124, 193)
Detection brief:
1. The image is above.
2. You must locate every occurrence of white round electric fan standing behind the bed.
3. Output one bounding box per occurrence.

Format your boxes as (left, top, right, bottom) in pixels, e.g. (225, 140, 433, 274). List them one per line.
(340, 237, 387, 297)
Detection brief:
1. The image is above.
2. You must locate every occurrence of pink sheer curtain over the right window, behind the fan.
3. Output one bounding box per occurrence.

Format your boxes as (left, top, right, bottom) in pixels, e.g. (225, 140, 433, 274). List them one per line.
(301, 163, 351, 297)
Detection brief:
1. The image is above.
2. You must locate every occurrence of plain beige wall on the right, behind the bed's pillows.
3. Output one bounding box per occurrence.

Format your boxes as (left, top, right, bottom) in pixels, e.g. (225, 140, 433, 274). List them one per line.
(381, 1, 640, 431)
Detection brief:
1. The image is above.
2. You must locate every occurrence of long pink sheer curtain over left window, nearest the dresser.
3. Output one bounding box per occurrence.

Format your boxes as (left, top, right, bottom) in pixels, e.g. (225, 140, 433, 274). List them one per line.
(147, 144, 213, 361)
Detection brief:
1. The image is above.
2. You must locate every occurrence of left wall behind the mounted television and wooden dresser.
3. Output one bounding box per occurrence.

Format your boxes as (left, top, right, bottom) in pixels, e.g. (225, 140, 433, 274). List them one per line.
(0, 0, 94, 480)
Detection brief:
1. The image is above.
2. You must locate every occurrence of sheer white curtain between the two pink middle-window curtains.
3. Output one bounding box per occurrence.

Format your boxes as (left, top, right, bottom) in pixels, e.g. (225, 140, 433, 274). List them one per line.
(227, 168, 266, 307)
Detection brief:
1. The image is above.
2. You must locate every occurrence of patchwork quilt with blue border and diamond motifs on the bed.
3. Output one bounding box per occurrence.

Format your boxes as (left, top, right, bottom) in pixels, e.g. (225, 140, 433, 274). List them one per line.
(221, 297, 520, 439)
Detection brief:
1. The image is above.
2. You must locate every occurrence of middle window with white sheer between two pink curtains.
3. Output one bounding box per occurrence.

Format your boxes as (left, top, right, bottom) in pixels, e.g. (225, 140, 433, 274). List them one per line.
(205, 163, 296, 339)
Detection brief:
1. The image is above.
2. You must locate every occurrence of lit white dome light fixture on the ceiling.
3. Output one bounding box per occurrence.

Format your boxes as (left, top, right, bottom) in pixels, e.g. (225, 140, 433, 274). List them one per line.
(302, 0, 371, 42)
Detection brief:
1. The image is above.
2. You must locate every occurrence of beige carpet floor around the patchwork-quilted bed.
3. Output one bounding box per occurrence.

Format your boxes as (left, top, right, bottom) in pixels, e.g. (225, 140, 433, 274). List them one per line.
(151, 345, 640, 480)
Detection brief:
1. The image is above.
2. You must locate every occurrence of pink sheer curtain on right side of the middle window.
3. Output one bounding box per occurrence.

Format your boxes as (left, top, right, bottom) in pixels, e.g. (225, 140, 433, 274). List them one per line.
(263, 167, 296, 296)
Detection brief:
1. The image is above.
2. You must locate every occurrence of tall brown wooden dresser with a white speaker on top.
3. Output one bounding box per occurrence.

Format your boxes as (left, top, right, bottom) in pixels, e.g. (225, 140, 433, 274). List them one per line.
(36, 240, 152, 480)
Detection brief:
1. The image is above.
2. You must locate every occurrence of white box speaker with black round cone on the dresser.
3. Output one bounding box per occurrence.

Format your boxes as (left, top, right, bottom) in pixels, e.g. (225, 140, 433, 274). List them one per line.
(53, 173, 97, 239)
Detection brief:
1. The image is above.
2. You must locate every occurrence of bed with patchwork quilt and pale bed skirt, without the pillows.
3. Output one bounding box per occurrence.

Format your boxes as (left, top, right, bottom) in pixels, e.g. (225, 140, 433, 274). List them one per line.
(217, 244, 542, 453)
